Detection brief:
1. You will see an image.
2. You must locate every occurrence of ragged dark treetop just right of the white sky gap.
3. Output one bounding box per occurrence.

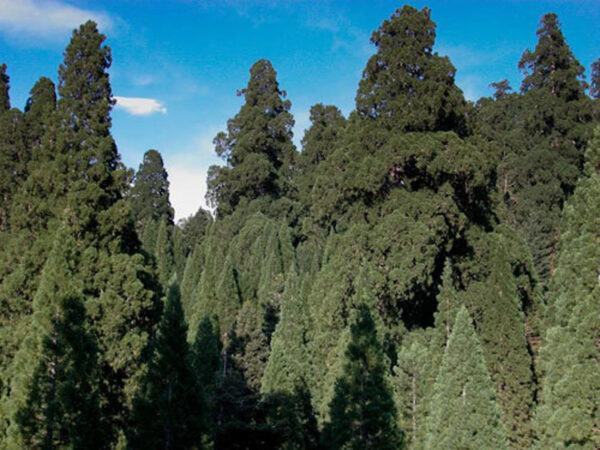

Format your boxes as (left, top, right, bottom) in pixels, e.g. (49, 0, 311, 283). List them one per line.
(207, 59, 295, 216)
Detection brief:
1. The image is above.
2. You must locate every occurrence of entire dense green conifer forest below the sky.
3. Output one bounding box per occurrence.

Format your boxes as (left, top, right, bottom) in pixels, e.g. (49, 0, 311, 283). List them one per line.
(0, 6, 600, 450)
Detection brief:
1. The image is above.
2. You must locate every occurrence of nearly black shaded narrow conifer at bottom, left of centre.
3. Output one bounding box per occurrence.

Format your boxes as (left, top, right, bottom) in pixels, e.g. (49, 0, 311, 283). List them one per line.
(130, 284, 205, 449)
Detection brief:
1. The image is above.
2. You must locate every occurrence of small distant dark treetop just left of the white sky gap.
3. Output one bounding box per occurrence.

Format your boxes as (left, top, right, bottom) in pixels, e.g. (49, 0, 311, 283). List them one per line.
(129, 150, 173, 230)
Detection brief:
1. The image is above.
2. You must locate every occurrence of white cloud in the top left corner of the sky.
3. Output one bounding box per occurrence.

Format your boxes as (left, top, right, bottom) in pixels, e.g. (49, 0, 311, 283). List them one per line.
(0, 0, 113, 37)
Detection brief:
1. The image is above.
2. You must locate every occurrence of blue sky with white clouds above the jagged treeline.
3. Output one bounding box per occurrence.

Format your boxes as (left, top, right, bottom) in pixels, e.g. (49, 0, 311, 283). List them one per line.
(0, 0, 600, 218)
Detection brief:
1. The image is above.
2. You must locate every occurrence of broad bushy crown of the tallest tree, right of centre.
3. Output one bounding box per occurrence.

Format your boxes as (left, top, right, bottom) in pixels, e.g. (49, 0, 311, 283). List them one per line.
(356, 5, 465, 133)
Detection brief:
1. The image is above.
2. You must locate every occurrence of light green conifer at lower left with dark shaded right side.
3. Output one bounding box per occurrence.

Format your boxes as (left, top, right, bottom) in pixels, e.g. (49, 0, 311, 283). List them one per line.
(5, 227, 101, 449)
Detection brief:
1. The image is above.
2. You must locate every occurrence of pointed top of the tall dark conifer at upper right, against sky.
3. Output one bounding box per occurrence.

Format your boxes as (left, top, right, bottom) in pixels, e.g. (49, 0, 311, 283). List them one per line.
(519, 13, 586, 100)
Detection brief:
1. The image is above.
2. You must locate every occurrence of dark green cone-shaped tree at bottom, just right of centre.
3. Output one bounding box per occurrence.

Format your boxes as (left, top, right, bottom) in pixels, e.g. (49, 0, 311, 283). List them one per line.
(323, 304, 402, 449)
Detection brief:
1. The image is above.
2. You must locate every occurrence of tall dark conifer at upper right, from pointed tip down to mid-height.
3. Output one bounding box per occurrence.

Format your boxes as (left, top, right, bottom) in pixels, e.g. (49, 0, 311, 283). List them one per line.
(508, 13, 591, 281)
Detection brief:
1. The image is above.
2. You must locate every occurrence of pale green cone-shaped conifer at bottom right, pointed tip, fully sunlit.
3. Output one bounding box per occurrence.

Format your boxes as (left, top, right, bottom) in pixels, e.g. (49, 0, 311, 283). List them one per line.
(426, 307, 508, 449)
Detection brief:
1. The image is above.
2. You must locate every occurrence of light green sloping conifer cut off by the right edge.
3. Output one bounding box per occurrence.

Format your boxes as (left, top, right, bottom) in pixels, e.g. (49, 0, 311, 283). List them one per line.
(535, 128, 600, 449)
